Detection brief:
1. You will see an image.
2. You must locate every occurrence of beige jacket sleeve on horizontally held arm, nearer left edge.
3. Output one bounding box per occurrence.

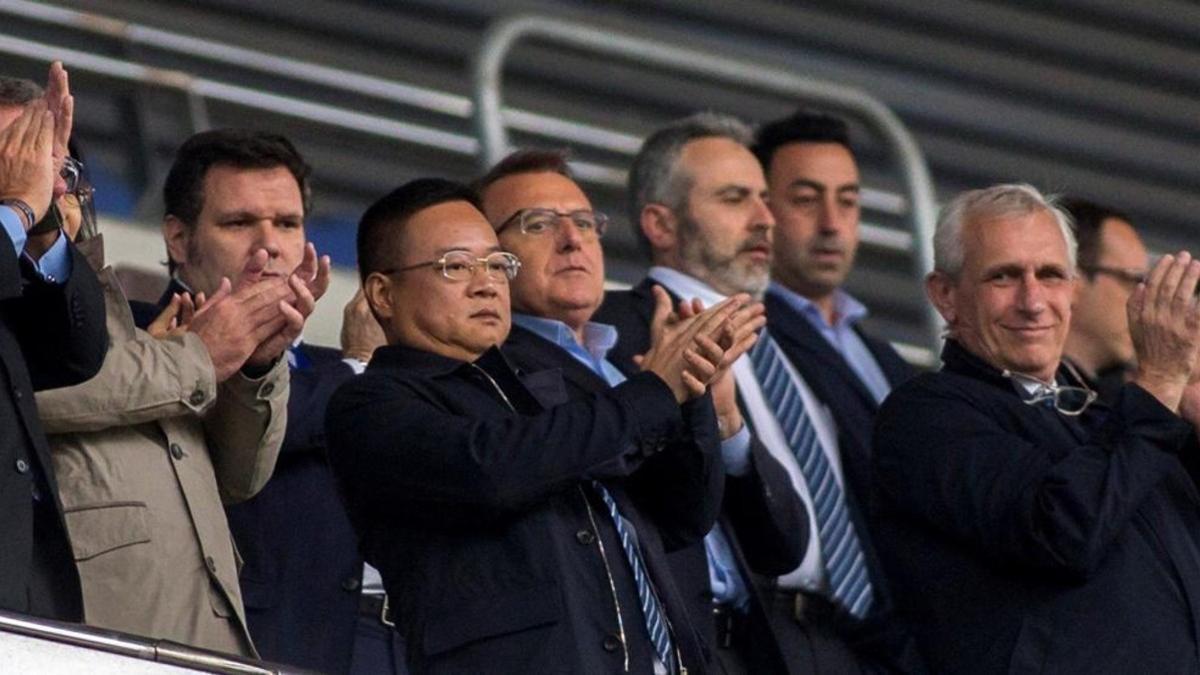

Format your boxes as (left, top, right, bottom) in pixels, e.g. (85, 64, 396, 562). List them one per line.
(37, 330, 217, 434)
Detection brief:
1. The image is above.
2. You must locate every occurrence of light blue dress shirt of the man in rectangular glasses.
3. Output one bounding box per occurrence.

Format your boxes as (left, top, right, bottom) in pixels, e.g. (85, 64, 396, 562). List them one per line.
(512, 312, 750, 611)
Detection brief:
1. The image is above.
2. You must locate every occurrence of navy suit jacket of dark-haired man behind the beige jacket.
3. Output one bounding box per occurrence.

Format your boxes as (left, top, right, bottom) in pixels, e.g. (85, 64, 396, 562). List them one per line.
(136, 280, 362, 674)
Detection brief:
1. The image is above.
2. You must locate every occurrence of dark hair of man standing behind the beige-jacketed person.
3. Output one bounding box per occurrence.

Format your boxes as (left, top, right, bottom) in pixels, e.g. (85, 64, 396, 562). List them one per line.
(162, 129, 312, 227)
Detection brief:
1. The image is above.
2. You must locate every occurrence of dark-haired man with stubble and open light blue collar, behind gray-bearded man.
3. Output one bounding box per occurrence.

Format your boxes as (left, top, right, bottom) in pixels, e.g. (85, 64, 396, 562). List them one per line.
(752, 109, 913, 526)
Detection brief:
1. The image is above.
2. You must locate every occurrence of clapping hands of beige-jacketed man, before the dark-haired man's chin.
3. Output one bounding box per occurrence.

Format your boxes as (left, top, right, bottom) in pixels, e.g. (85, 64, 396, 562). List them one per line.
(146, 244, 330, 382)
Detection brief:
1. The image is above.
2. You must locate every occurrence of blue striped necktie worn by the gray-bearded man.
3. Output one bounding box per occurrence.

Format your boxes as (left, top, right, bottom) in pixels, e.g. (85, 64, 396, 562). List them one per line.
(750, 330, 874, 617)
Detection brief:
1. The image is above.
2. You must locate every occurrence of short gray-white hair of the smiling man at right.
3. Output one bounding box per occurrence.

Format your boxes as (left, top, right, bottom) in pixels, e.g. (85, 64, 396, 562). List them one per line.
(934, 183, 1078, 279)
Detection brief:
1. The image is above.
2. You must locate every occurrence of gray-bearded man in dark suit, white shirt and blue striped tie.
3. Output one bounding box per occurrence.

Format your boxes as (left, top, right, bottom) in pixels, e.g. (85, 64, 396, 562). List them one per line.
(598, 113, 920, 673)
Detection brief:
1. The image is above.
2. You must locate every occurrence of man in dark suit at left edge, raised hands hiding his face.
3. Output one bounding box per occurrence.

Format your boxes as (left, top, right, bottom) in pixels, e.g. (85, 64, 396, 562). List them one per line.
(0, 62, 108, 621)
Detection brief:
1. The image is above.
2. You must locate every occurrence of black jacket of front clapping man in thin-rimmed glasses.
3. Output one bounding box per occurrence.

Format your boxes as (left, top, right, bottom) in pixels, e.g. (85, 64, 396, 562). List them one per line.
(326, 346, 716, 673)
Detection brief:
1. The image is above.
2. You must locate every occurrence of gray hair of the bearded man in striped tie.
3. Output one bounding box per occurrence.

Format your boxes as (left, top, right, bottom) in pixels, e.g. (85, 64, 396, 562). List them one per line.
(628, 112, 754, 252)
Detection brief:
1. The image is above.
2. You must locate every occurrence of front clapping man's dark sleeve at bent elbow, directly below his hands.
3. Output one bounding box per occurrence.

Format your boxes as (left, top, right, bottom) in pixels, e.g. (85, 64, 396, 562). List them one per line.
(629, 395, 725, 551)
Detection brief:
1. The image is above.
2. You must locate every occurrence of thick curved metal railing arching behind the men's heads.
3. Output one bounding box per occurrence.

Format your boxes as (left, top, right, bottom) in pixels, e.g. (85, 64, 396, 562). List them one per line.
(473, 16, 942, 347)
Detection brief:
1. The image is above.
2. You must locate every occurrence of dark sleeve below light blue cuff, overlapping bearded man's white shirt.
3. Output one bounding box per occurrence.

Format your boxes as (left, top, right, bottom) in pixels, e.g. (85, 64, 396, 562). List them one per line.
(725, 435, 810, 577)
